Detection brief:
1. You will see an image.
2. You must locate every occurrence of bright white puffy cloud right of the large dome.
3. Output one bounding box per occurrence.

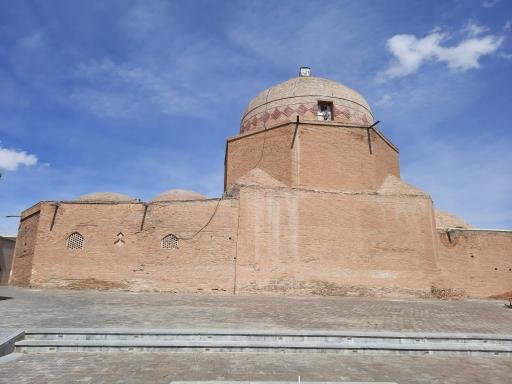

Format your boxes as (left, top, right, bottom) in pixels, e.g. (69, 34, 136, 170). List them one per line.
(379, 24, 503, 78)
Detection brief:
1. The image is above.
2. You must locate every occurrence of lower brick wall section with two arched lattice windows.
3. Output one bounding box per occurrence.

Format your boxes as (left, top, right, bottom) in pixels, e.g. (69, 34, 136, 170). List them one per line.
(23, 199, 238, 292)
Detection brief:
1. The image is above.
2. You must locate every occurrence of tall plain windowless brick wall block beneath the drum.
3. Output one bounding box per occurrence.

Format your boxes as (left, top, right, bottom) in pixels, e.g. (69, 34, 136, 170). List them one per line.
(237, 187, 438, 295)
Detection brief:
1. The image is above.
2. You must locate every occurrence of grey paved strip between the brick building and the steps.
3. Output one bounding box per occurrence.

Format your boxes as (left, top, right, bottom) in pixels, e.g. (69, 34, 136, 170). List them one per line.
(0, 287, 512, 334)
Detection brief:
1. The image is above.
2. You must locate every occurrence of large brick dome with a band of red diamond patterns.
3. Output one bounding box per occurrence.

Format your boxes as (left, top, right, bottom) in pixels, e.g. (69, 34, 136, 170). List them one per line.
(240, 76, 373, 133)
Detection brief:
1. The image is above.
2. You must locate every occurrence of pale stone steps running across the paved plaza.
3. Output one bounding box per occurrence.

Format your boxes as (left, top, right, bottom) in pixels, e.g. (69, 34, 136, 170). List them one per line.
(16, 329, 512, 356)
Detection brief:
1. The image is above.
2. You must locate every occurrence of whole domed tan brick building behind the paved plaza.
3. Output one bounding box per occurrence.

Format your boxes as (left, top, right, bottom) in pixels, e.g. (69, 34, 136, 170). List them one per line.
(10, 68, 512, 297)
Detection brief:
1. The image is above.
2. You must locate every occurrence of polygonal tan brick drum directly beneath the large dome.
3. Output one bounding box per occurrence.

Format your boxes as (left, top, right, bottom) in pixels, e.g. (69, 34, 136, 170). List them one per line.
(226, 122, 400, 191)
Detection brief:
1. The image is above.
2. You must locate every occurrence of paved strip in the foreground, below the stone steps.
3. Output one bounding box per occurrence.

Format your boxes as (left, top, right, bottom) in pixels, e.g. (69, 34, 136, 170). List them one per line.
(0, 353, 512, 384)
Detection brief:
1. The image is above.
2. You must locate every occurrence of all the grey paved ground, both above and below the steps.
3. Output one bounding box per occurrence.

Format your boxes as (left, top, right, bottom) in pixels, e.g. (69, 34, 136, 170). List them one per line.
(0, 287, 512, 384)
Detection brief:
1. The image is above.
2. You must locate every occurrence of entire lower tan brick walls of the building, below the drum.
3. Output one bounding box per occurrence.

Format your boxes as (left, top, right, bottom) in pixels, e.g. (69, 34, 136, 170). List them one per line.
(11, 185, 512, 297)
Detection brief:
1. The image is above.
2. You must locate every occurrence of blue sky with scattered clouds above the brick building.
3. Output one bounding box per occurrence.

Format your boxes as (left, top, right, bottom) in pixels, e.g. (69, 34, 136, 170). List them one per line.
(0, 0, 512, 234)
